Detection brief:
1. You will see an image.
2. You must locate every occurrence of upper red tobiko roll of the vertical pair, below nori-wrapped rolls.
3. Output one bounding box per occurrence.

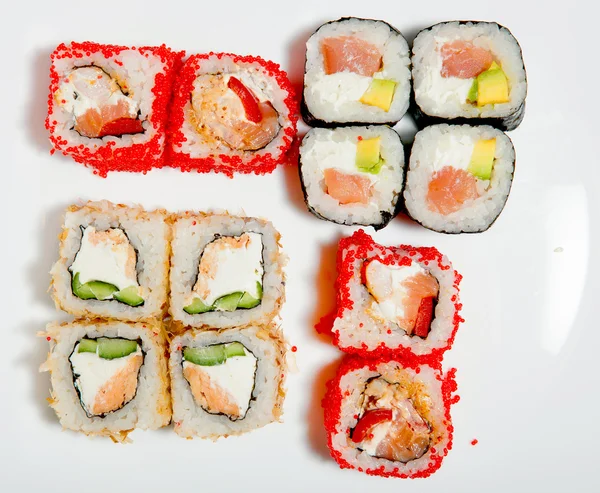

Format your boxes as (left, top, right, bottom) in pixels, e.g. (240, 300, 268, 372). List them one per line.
(332, 230, 462, 362)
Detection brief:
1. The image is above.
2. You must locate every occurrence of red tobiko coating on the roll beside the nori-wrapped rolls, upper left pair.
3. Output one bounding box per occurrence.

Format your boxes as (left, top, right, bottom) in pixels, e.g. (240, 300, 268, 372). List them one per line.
(167, 52, 299, 177)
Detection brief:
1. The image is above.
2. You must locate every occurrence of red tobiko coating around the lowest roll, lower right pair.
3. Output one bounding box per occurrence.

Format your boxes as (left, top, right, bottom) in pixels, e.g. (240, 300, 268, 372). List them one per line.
(321, 355, 460, 479)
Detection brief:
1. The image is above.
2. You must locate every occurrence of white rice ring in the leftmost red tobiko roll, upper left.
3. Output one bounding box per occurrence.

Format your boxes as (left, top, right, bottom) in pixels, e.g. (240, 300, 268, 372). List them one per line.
(49, 45, 166, 151)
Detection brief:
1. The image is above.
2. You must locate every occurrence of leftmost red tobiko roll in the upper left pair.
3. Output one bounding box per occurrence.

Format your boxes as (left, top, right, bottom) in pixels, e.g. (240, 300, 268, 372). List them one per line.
(46, 42, 183, 176)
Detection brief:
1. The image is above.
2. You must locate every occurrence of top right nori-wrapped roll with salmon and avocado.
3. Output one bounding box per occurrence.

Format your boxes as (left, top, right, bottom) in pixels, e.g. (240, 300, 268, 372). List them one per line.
(412, 21, 527, 130)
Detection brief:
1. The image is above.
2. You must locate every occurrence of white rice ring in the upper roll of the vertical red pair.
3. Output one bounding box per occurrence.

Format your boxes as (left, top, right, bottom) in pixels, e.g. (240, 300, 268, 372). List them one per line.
(333, 237, 458, 356)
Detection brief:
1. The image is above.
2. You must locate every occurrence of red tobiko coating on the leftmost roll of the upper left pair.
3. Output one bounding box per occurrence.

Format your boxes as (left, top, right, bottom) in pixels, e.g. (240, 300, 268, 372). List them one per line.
(46, 41, 184, 177)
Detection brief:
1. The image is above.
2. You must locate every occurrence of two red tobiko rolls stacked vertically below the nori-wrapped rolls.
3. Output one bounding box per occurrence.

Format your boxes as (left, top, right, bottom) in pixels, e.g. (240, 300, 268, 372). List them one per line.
(317, 230, 463, 478)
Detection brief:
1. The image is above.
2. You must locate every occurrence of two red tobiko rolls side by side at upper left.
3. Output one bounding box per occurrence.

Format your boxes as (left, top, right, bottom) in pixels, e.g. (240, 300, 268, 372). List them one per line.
(46, 42, 298, 176)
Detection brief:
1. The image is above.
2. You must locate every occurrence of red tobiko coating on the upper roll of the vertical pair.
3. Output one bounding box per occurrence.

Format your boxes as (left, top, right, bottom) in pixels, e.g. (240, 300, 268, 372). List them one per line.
(324, 229, 464, 364)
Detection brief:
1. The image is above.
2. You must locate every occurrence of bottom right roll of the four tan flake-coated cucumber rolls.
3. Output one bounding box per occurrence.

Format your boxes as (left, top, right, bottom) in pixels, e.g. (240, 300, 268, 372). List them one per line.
(169, 325, 286, 439)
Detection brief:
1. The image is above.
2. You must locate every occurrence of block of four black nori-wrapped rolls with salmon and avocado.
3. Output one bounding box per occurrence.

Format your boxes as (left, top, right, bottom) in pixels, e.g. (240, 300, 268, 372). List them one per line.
(300, 18, 527, 233)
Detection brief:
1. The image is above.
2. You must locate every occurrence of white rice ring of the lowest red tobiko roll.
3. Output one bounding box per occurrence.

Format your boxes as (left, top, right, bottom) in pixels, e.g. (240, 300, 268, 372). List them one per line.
(330, 361, 450, 475)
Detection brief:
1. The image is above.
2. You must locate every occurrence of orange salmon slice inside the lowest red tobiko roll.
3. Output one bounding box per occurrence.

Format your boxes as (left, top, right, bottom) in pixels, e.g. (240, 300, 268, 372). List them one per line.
(375, 399, 431, 463)
